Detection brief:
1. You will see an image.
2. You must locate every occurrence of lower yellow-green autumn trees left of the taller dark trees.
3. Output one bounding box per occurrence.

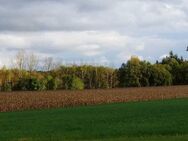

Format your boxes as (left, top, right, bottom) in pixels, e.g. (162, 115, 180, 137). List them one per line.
(0, 65, 118, 91)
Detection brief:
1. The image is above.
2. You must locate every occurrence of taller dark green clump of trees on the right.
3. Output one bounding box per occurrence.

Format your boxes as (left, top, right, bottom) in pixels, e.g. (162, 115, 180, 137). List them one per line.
(118, 52, 188, 87)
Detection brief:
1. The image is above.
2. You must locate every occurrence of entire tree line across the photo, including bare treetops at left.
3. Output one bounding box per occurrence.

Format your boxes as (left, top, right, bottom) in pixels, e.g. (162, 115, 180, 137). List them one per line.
(0, 50, 188, 91)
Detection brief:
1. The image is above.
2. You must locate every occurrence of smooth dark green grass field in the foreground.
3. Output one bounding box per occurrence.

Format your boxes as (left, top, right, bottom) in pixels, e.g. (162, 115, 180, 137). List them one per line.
(0, 99, 188, 141)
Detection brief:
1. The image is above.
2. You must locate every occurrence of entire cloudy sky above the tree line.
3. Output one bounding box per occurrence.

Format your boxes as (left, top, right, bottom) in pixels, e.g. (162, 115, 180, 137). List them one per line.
(0, 0, 188, 66)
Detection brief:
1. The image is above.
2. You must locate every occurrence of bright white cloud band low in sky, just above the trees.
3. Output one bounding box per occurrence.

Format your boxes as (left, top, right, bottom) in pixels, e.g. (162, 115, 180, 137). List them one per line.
(0, 31, 187, 64)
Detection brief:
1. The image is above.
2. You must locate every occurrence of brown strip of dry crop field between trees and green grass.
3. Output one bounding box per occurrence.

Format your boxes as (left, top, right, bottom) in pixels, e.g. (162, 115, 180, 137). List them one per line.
(0, 86, 188, 112)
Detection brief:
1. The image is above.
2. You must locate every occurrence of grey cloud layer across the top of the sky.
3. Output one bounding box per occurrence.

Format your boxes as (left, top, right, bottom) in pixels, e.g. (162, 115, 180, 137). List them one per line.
(0, 0, 188, 32)
